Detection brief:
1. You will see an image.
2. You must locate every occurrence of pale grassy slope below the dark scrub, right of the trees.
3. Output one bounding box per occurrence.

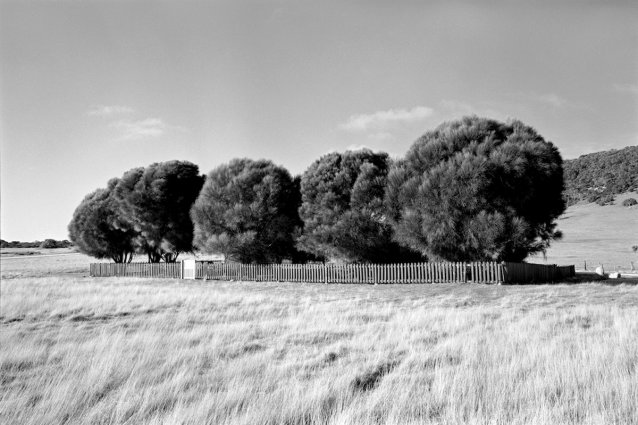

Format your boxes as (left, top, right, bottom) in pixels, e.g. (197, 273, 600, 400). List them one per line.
(528, 193, 638, 271)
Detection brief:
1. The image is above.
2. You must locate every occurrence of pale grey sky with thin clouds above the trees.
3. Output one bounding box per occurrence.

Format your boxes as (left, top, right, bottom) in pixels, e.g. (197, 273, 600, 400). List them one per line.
(0, 0, 638, 241)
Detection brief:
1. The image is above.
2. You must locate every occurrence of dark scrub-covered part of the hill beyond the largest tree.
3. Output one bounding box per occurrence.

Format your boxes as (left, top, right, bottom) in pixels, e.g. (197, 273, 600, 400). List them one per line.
(563, 146, 638, 205)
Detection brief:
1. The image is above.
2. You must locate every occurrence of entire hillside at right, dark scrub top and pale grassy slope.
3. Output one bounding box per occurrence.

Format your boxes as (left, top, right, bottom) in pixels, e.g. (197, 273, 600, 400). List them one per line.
(540, 146, 638, 271)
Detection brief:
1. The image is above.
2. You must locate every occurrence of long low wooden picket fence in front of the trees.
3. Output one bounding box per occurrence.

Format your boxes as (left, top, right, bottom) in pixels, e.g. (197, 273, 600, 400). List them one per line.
(91, 260, 575, 284)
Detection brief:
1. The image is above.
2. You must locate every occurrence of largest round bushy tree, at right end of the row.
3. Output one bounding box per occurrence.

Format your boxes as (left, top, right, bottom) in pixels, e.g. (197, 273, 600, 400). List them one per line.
(386, 116, 565, 261)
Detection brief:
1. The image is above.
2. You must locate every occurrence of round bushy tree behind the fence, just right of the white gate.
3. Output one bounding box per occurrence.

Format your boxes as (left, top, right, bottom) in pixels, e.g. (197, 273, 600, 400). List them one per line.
(191, 159, 301, 263)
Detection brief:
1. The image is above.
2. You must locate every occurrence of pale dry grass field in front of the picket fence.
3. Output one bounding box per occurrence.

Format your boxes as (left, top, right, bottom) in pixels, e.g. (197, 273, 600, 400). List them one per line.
(0, 268, 638, 425)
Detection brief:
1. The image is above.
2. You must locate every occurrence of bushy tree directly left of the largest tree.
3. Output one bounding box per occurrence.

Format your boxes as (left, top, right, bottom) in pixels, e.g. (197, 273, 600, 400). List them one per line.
(298, 150, 420, 263)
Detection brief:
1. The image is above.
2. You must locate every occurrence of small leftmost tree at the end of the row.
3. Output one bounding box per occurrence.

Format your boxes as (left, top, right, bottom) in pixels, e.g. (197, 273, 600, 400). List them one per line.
(69, 179, 137, 263)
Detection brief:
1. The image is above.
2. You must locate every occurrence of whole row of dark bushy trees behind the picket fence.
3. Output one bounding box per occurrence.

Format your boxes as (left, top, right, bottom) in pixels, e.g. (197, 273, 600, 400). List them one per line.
(69, 117, 565, 263)
